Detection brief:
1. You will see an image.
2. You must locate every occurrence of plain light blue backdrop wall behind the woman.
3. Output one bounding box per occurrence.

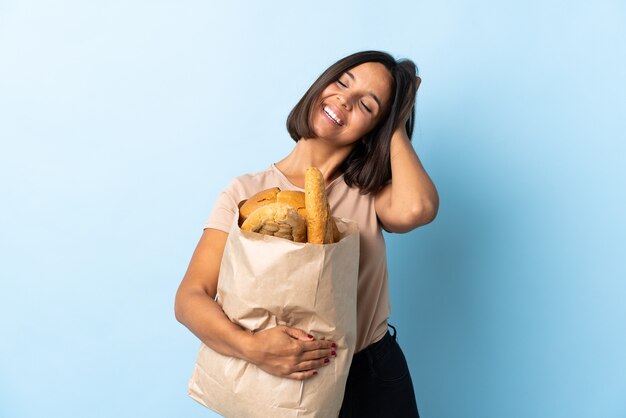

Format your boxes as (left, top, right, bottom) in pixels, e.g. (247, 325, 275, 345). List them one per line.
(0, 0, 626, 418)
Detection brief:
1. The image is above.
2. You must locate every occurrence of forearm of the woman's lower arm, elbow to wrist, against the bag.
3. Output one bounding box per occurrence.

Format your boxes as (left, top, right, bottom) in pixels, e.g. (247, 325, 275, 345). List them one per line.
(176, 290, 252, 361)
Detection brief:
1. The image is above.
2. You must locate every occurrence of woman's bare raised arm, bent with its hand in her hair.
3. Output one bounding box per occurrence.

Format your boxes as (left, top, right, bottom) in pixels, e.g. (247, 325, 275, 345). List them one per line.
(375, 77, 439, 233)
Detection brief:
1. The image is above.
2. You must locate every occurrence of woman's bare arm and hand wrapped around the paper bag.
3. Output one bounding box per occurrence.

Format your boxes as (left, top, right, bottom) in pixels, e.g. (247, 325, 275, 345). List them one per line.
(174, 228, 333, 379)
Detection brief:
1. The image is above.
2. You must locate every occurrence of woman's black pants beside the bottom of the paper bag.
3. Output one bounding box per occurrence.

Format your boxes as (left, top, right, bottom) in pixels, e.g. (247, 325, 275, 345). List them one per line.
(339, 325, 419, 418)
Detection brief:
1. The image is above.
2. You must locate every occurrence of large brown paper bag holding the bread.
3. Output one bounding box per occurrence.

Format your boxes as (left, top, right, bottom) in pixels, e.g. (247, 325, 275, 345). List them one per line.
(189, 214, 359, 418)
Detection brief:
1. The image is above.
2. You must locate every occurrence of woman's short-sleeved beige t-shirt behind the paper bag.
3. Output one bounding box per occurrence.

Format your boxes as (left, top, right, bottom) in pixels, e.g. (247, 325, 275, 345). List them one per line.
(204, 164, 390, 351)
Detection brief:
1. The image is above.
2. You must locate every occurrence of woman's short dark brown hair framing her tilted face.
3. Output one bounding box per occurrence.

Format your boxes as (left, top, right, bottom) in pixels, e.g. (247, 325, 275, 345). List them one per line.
(287, 51, 417, 194)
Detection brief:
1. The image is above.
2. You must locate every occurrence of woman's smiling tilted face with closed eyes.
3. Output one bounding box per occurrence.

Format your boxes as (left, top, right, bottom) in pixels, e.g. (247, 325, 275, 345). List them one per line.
(311, 62, 393, 146)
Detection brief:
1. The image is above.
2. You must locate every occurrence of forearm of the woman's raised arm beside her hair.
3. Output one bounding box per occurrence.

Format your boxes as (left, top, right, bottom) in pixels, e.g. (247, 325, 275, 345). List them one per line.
(389, 127, 439, 224)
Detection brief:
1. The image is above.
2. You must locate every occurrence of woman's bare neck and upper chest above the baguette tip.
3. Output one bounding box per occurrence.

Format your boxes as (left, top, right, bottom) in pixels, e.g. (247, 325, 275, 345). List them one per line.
(276, 138, 352, 187)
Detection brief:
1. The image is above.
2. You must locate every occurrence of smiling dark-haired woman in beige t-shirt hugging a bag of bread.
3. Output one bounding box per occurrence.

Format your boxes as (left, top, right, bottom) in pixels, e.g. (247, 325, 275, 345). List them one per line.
(175, 51, 438, 417)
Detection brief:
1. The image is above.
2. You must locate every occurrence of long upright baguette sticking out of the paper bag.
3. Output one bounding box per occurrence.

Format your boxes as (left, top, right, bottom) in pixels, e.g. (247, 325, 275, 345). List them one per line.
(304, 167, 332, 244)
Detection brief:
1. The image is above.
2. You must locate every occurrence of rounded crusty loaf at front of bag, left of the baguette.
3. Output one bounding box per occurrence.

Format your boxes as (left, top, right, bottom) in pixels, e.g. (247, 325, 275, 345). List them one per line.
(241, 203, 306, 242)
